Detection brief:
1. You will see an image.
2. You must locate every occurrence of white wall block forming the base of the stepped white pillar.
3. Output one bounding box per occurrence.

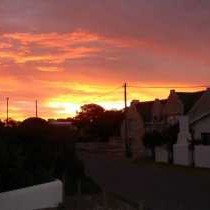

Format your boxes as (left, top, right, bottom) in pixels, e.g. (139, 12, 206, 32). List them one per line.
(173, 144, 191, 166)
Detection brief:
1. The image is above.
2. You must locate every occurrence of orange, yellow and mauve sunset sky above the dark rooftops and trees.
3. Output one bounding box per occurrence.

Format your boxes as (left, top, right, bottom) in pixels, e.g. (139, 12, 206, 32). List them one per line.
(0, 0, 210, 120)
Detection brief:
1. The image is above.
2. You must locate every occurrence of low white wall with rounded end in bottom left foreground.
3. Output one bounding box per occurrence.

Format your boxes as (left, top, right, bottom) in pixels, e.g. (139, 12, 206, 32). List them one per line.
(0, 180, 63, 210)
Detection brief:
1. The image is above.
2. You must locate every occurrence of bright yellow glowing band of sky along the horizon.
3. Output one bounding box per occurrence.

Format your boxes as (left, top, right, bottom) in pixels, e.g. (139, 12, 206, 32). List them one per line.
(0, 82, 207, 121)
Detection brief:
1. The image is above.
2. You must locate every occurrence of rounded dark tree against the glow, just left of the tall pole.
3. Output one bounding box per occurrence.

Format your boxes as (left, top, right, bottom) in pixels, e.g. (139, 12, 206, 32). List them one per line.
(74, 104, 123, 141)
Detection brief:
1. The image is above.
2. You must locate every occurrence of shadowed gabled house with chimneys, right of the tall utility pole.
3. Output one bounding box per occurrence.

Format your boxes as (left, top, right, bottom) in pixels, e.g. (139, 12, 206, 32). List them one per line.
(121, 86, 210, 159)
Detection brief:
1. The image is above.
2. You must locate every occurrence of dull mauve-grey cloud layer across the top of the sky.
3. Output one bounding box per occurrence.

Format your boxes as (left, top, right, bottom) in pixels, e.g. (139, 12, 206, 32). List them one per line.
(0, 0, 210, 56)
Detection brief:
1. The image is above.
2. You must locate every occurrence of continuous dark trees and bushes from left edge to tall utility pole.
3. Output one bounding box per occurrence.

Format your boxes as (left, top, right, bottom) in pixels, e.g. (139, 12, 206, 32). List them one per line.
(0, 104, 123, 193)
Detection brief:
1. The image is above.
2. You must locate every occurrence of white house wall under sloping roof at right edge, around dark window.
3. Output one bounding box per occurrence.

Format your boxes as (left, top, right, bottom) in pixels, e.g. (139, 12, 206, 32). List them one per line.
(193, 115, 210, 139)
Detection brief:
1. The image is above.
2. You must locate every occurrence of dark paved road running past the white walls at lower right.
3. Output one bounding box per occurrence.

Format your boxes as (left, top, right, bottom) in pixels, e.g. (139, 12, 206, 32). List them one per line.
(83, 156, 210, 210)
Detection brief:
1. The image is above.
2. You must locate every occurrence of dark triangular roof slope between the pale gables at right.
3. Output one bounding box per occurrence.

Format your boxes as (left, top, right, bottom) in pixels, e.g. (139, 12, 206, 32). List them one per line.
(176, 91, 205, 114)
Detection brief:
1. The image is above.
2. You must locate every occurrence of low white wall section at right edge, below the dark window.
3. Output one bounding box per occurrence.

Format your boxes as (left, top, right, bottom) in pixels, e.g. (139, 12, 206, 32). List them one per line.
(195, 146, 210, 168)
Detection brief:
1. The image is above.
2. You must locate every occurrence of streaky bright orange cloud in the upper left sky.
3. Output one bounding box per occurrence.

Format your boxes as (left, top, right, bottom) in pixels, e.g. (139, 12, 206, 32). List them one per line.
(0, 32, 106, 64)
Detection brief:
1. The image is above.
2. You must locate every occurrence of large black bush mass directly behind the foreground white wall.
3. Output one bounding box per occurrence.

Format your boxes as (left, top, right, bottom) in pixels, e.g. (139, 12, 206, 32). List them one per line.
(0, 118, 84, 192)
